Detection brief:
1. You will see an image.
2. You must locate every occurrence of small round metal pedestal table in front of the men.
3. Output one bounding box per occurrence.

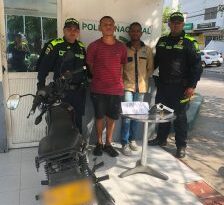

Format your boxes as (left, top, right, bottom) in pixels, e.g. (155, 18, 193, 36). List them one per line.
(119, 113, 176, 180)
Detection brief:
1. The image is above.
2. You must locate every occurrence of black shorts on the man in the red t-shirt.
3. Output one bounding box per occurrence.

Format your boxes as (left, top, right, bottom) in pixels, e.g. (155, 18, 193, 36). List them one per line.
(91, 93, 122, 120)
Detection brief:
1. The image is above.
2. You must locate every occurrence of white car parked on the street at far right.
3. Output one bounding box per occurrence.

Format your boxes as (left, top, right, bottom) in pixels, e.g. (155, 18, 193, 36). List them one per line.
(201, 50, 223, 68)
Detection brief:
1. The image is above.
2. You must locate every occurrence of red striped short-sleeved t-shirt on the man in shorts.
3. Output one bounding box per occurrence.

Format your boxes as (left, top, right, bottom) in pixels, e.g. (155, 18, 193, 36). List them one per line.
(87, 38, 127, 95)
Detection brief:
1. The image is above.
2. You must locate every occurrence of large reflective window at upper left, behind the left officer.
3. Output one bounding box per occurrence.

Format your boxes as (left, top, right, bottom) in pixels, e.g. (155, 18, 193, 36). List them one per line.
(4, 0, 57, 72)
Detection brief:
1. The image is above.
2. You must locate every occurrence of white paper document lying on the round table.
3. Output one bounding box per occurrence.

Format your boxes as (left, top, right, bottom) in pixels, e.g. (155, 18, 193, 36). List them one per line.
(121, 101, 149, 115)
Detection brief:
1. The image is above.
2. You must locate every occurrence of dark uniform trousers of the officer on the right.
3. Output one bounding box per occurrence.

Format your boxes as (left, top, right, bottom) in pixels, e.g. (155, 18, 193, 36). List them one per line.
(156, 83, 188, 147)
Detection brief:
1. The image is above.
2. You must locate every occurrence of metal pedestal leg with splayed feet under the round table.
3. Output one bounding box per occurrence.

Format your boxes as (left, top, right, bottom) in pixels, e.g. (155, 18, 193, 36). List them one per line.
(119, 122, 168, 180)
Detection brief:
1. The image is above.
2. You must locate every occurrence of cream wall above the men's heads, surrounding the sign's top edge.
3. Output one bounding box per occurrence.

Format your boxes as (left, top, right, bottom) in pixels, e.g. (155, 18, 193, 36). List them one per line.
(58, 0, 163, 46)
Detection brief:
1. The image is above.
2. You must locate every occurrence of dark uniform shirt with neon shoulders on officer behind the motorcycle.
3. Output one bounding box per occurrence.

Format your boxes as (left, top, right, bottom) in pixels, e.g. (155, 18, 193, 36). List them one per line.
(38, 38, 86, 86)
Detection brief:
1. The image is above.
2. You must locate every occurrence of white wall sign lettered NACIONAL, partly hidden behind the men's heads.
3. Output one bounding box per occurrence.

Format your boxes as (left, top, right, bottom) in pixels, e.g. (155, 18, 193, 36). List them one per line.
(80, 20, 152, 46)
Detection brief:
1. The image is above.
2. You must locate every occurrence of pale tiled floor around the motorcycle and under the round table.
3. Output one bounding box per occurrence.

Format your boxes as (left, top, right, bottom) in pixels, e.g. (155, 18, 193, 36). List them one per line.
(0, 144, 201, 205)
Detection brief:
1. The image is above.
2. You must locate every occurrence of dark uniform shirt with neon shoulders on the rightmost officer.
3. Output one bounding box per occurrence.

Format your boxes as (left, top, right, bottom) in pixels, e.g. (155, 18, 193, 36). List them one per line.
(155, 31, 202, 87)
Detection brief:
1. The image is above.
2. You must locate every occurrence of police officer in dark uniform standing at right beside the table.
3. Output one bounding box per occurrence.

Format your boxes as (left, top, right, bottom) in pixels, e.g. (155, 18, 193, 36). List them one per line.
(148, 12, 202, 158)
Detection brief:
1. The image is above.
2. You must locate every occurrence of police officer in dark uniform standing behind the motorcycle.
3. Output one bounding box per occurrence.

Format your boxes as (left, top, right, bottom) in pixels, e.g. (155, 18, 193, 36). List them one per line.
(37, 18, 87, 133)
